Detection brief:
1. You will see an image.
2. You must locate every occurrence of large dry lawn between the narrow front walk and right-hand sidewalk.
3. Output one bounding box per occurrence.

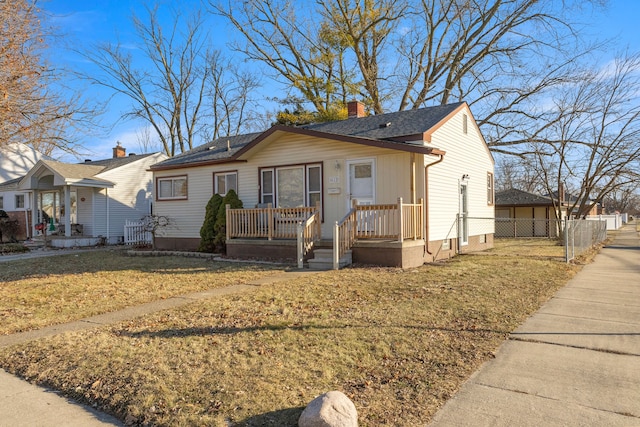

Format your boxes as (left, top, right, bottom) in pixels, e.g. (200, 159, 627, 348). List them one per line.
(0, 242, 592, 426)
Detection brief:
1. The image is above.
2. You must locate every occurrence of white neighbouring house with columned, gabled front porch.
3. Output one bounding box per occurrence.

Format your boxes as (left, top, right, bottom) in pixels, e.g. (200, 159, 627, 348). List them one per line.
(12, 144, 167, 247)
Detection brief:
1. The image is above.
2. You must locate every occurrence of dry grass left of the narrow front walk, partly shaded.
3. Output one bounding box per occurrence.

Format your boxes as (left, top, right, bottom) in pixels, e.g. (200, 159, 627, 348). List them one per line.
(0, 250, 281, 335)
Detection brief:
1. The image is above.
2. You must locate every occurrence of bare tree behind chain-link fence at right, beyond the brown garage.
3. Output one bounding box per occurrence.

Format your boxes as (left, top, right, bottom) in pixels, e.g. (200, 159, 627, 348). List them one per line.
(528, 55, 640, 216)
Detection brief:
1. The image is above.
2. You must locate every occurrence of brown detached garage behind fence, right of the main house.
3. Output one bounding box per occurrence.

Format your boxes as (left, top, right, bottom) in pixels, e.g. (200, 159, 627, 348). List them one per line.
(495, 188, 567, 237)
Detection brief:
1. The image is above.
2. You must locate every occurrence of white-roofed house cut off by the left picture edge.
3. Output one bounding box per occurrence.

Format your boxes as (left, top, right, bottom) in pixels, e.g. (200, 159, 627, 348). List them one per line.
(0, 144, 48, 240)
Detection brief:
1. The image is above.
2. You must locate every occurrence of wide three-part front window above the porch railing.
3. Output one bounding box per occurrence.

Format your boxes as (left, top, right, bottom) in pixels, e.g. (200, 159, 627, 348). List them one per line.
(260, 164, 322, 208)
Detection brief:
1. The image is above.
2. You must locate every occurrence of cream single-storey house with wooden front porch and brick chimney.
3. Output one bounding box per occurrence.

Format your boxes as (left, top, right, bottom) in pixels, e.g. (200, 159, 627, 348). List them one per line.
(151, 102, 494, 267)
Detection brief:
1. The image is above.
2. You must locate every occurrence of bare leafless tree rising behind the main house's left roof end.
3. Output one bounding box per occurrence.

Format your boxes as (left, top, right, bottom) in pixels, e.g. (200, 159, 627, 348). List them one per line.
(82, 5, 257, 156)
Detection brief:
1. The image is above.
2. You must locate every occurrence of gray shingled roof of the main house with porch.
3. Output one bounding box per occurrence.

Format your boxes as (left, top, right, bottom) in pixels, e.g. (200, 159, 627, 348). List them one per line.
(152, 102, 463, 168)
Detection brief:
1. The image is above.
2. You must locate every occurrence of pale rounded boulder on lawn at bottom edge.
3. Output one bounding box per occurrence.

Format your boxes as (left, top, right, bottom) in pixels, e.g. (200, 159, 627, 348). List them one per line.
(298, 391, 358, 427)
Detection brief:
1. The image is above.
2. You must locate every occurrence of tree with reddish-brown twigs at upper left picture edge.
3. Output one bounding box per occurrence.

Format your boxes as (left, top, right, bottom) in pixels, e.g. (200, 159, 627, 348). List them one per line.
(0, 0, 96, 155)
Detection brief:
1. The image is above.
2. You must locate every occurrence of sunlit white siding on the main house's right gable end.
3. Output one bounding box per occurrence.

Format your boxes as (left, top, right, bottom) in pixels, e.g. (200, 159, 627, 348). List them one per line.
(426, 108, 494, 241)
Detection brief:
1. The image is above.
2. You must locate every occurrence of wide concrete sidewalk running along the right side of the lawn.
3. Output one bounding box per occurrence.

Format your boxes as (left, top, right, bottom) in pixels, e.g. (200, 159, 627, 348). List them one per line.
(430, 225, 640, 427)
